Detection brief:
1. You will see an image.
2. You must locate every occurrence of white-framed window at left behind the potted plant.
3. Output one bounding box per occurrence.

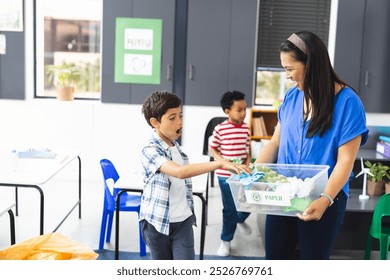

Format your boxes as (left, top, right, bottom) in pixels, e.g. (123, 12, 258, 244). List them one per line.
(35, 0, 103, 99)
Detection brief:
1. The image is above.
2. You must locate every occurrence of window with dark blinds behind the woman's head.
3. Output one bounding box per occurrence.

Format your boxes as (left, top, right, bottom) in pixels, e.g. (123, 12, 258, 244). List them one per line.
(254, 0, 332, 106)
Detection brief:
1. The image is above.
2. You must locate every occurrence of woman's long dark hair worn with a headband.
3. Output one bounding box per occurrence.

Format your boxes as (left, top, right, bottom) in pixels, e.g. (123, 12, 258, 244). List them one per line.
(280, 31, 349, 137)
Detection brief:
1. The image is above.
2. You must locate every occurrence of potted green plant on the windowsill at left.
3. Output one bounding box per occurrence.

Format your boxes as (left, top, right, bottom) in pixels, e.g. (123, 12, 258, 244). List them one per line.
(45, 62, 81, 100)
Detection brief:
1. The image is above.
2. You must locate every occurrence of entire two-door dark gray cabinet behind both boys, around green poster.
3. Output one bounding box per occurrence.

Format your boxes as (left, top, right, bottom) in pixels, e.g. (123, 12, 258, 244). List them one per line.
(102, 0, 258, 106)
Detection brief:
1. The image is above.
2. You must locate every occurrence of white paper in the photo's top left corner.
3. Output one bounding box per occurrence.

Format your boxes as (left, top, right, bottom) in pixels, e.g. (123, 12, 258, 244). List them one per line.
(0, 0, 23, 32)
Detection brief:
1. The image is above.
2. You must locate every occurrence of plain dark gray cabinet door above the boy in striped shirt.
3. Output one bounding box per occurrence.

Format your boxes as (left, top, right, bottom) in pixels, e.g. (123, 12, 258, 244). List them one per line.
(185, 0, 257, 106)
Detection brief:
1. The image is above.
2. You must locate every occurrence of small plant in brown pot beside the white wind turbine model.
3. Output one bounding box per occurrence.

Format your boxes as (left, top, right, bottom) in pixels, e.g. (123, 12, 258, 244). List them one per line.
(364, 161, 390, 196)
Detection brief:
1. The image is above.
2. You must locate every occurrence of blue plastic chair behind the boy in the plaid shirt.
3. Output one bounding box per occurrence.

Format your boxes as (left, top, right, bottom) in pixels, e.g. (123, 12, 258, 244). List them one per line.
(99, 159, 146, 256)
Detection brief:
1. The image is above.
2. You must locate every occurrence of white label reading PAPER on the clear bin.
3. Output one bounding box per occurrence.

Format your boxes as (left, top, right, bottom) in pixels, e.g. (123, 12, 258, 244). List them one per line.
(245, 190, 291, 206)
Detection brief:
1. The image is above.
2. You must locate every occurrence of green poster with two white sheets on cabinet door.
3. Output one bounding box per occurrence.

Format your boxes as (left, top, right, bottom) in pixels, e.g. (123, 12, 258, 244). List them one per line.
(115, 18, 162, 84)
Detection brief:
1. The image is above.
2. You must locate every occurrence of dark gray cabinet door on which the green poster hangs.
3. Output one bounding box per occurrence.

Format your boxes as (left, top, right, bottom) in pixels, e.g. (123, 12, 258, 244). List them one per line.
(101, 0, 176, 104)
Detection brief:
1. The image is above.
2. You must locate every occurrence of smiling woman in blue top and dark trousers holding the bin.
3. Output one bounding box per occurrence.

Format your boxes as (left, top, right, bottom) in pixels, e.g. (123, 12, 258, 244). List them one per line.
(256, 31, 368, 259)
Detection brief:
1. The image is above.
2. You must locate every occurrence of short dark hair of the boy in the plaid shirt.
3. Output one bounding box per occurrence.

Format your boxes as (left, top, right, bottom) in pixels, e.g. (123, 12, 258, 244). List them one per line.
(142, 91, 181, 127)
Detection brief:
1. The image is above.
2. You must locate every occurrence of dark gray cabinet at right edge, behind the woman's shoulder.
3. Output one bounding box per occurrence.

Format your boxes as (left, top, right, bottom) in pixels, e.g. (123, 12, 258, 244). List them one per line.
(335, 0, 390, 113)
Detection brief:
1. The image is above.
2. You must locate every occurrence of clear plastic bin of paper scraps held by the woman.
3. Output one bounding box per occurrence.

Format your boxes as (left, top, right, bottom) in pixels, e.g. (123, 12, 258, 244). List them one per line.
(227, 164, 329, 216)
